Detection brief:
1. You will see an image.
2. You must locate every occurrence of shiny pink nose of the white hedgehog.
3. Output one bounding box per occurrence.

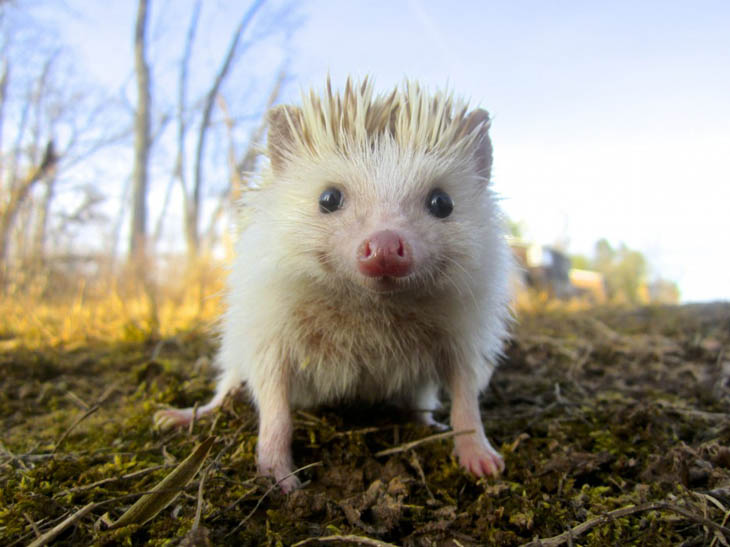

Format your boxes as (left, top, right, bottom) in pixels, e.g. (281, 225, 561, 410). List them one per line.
(357, 230, 413, 277)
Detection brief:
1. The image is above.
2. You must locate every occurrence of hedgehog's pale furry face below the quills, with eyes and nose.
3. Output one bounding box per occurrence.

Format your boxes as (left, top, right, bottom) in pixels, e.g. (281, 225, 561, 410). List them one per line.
(270, 101, 494, 293)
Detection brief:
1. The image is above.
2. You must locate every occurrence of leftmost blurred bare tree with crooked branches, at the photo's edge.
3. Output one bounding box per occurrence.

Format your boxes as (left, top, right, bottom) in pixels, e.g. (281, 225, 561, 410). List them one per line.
(0, 9, 127, 279)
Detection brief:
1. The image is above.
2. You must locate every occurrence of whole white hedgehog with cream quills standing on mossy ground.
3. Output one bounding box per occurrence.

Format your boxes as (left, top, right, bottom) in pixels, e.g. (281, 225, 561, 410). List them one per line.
(155, 79, 512, 491)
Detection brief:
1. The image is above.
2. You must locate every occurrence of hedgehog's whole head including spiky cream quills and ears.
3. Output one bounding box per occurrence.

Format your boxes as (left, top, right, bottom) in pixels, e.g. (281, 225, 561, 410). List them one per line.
(260, 80, 496, 292)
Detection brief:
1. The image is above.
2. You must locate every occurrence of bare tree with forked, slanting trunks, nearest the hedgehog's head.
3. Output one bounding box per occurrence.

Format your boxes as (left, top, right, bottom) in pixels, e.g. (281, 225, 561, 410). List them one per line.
(142, 0, 294, 263)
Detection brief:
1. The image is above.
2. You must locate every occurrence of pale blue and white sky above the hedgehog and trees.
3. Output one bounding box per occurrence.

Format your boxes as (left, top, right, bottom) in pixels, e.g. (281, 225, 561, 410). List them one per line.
(22, 0, 730, 301)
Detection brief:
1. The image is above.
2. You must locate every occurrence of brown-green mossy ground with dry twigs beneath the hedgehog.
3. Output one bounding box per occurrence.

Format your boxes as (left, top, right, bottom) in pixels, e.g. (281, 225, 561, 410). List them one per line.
(0, 304, 730, 547)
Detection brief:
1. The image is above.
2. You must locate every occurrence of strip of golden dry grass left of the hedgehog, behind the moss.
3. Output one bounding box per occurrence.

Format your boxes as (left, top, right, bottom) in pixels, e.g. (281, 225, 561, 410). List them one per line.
(0, 262, 225, 348)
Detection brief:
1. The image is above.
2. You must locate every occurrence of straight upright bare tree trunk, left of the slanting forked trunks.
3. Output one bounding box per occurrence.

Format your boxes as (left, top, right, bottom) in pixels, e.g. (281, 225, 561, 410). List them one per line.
(129, 0, 151, 263)
